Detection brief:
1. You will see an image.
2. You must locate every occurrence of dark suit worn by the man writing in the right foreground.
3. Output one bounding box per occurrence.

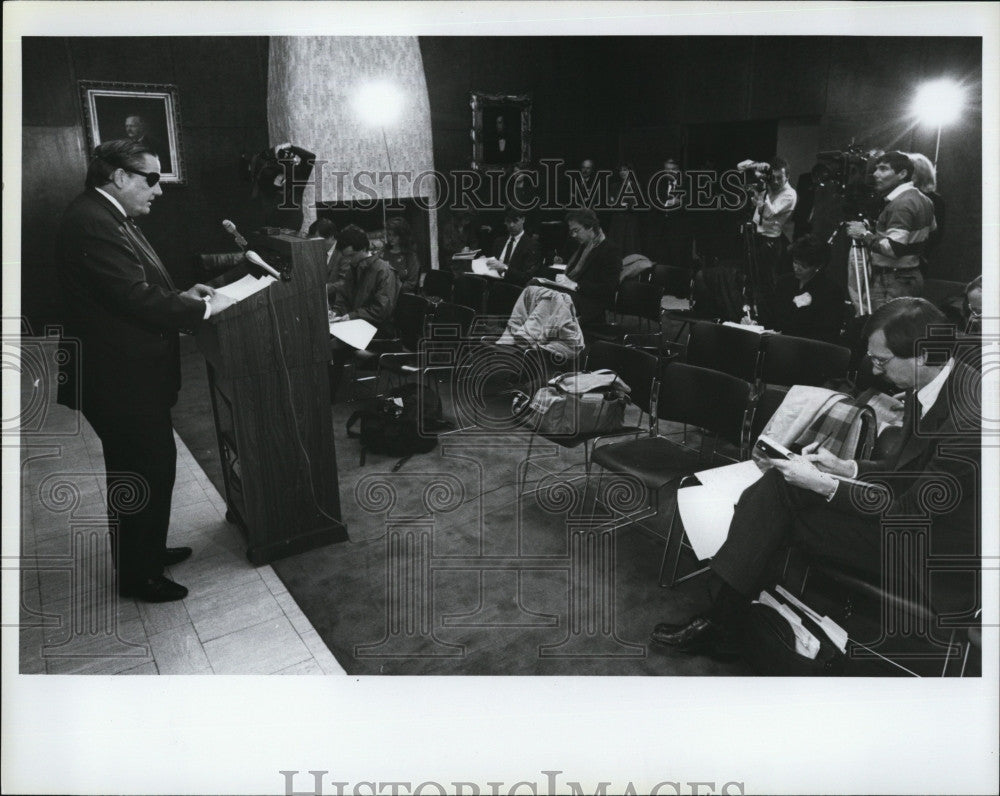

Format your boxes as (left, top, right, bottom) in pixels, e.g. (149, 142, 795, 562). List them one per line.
(711, 363, 982, 595)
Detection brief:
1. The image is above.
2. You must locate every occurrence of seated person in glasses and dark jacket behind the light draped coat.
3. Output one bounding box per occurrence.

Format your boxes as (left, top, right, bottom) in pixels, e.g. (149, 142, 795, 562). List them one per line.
(556, 209, 622, 326)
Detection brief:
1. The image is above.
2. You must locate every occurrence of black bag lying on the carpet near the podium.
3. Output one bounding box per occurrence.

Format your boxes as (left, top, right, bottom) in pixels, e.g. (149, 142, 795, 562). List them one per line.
(347, 384, 450, 472)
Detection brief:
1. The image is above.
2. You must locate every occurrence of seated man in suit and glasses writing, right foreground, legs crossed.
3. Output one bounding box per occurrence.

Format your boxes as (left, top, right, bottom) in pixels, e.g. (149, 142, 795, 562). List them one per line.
(650, 297, 982, 652)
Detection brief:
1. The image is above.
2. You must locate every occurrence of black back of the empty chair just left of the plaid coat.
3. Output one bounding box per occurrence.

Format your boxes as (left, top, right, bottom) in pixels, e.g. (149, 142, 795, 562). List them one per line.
(657, 361, 753, 455)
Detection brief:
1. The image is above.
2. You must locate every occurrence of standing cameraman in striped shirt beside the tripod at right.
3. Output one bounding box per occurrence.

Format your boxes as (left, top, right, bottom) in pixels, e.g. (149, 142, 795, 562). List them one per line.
(847, 152, 936, 310)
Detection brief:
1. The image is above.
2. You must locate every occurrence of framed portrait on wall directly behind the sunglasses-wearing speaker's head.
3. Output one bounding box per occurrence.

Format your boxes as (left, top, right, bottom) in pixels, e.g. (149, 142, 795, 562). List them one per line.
(80, 80, 185, 185)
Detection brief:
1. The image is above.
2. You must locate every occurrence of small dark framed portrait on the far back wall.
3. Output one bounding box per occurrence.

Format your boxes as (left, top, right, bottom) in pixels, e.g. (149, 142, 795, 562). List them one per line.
(469, 91, 531, 169)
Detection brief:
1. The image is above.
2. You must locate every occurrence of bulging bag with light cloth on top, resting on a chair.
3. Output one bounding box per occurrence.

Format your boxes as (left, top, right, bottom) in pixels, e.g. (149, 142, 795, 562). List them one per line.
(515, 369, 631, 437)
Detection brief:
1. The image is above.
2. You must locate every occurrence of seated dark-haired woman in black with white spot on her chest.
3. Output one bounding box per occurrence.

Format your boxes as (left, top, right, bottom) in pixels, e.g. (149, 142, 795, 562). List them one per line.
(764, 230, 847, 343)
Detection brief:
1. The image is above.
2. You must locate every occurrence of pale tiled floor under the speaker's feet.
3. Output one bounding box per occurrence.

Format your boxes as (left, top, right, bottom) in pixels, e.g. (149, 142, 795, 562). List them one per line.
(15, 384, 344, 674)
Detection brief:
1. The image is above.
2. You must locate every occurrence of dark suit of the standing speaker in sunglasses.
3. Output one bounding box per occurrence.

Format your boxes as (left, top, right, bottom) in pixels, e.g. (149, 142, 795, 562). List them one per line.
(58, 189, 205, 586)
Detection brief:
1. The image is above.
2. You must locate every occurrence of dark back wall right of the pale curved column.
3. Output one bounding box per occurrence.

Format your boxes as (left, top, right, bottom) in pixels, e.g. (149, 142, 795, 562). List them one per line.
(421, 36, 982, 279)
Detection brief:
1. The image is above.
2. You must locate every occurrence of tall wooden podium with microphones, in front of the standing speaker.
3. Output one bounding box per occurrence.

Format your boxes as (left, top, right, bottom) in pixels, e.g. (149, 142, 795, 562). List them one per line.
(197, 234, 347, 565)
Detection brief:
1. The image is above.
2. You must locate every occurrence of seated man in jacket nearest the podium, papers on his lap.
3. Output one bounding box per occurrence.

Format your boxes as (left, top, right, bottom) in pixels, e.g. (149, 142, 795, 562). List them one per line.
(329, 224, 399, 401)
